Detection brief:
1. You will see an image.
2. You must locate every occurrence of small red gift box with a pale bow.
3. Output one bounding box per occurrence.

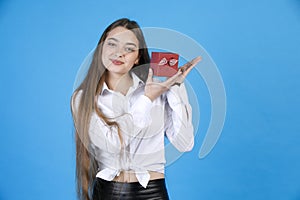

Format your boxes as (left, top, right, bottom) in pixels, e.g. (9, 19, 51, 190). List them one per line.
(150, 52, 179, 77)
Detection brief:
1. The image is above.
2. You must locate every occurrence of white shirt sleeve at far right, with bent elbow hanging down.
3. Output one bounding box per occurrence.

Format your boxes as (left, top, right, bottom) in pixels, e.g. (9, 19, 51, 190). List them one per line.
(165, 83, 194, 152)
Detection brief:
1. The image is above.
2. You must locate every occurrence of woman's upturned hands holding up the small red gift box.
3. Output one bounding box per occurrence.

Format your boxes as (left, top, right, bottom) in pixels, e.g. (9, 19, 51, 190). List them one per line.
(145, 56, 202, 101)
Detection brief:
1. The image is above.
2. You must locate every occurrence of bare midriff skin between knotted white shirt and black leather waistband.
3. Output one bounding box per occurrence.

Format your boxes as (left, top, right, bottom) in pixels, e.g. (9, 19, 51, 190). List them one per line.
(113, 171, 165, 183)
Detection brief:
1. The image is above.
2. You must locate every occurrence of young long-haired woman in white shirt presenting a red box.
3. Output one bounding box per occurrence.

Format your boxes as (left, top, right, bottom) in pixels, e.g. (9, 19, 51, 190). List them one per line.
(71, 19, 201, 200)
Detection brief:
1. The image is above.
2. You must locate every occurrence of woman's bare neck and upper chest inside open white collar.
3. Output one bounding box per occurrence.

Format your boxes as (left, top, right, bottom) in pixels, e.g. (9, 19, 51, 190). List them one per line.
(105, 72, 133, 95)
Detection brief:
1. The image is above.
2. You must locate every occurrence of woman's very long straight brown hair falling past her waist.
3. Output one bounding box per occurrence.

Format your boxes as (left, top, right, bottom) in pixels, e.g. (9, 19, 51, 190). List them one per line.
(71, 18, 150, 200)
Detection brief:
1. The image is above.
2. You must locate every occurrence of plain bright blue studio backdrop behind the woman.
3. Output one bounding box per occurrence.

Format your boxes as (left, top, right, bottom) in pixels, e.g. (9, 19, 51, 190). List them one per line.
(0, 0, 300, 200)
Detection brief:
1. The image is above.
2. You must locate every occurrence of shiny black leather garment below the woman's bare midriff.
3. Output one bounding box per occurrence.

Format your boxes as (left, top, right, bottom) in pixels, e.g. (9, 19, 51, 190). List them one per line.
(93, 178, 169, 200)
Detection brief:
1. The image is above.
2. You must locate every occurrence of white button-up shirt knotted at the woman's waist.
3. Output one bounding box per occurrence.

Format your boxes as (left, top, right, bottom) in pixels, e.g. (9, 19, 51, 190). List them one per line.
(75, 73, 194, 187)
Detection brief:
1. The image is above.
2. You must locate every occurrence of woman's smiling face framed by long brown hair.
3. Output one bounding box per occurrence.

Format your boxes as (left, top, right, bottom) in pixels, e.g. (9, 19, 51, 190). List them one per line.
(102, 27, 139, 75)
